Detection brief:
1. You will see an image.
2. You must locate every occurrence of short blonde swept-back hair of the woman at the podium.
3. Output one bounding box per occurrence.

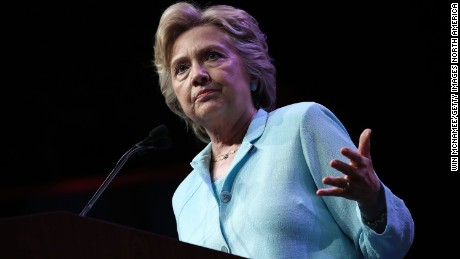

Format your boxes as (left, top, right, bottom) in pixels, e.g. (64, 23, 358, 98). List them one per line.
(154, 2, 276, 143)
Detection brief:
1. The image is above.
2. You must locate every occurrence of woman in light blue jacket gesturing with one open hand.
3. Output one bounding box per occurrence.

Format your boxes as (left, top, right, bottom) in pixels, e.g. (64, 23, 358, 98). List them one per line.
(154, 2, 414, 258)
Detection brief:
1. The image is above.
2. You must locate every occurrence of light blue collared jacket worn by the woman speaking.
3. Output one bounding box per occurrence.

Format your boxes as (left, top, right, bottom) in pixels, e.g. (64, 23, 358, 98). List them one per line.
(172, 102, 414, 259)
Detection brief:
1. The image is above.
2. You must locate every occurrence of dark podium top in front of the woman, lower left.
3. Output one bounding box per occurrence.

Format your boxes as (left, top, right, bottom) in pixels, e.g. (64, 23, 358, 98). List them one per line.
(0, 211, 241, 259)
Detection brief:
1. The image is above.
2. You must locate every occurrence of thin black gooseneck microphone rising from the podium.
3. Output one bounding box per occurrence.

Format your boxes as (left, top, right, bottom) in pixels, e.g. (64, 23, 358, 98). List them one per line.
(80, 124, 172, 217)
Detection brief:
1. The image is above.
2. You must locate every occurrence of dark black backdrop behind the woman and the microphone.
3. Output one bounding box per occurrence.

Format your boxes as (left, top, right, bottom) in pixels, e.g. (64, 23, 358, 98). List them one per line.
(0, 0, 452, 258)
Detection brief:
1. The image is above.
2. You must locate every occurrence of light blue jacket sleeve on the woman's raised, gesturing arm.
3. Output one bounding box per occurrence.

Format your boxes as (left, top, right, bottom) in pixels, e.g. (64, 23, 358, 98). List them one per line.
(300, 103, 414, 258)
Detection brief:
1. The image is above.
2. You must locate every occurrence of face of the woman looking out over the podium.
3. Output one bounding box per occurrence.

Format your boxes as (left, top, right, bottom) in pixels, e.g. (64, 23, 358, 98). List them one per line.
(170, 26, 254, 125)
